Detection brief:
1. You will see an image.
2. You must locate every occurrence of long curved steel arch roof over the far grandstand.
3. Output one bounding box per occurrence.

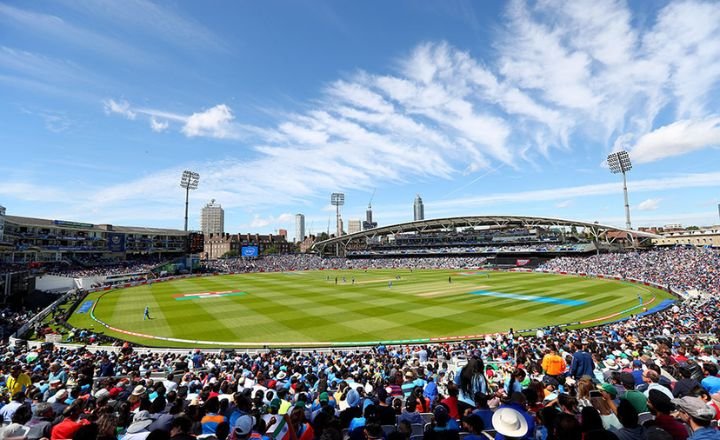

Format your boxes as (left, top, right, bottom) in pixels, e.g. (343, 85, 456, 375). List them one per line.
(312, 215, 660, 255)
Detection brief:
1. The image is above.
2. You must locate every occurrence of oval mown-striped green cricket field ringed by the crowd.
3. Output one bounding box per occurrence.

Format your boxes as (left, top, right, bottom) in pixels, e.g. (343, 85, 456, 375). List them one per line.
(70, 270, 671, 347)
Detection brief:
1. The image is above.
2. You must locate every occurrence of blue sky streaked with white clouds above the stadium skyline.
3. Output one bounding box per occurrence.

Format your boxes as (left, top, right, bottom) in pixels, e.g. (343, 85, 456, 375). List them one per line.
(0, 0, 720, 241)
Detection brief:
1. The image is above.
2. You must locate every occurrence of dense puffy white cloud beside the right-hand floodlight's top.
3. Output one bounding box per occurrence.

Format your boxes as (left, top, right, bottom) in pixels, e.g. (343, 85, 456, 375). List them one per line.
(630, 117, 720, 163)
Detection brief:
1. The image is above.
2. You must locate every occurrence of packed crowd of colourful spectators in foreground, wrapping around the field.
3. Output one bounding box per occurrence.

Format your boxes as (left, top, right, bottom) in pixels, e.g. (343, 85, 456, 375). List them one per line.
(0, 248, 720, 440)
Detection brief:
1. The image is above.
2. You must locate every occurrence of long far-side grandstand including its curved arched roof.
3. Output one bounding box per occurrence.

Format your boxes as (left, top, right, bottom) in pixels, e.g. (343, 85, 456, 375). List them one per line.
(313, 216, 660, 266)
